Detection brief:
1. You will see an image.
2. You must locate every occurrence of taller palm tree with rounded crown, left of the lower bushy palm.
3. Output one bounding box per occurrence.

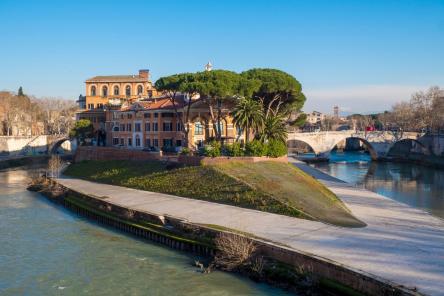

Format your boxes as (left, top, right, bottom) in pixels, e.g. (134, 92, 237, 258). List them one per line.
(231, 98, 263, 143)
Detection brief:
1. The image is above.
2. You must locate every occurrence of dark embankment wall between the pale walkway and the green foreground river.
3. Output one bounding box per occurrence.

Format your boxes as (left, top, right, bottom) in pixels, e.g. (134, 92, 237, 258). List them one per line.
(48, 180, 420, 296)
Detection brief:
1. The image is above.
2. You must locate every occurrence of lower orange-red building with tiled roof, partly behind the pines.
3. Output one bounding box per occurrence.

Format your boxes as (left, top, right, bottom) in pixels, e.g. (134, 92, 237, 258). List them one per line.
(106, 96, 244, 151)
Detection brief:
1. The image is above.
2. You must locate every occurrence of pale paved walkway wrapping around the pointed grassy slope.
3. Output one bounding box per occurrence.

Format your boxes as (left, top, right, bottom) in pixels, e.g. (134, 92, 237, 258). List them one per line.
(60, 163, 444, 295)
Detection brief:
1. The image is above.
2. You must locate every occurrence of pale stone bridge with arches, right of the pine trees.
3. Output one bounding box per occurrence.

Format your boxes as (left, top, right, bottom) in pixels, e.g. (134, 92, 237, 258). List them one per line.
(287, 130, 429, 160)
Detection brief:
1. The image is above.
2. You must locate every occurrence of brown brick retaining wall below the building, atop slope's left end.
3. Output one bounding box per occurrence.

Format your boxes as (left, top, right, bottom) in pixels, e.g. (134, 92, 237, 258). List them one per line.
(74, 146, 162, 162)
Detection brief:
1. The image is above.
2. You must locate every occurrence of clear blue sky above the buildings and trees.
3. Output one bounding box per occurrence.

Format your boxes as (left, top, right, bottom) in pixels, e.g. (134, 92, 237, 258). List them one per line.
(0, 0, 444, 113)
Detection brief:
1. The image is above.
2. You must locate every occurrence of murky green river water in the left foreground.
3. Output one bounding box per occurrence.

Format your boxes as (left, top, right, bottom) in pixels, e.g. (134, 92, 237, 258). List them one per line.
(0, 169, 292, 295)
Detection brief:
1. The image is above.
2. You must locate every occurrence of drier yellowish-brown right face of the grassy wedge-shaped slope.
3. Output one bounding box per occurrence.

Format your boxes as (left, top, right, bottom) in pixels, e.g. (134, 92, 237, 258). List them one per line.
(216, 162, 365, 227)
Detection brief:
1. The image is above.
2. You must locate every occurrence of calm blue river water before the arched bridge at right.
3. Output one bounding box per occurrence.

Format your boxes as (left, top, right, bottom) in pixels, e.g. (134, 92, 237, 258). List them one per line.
(313, 152, 444, 218)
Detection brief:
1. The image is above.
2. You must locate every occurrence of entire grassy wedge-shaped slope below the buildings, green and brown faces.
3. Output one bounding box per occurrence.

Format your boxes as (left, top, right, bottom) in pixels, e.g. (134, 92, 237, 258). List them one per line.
(65, 161, 363, 227)
